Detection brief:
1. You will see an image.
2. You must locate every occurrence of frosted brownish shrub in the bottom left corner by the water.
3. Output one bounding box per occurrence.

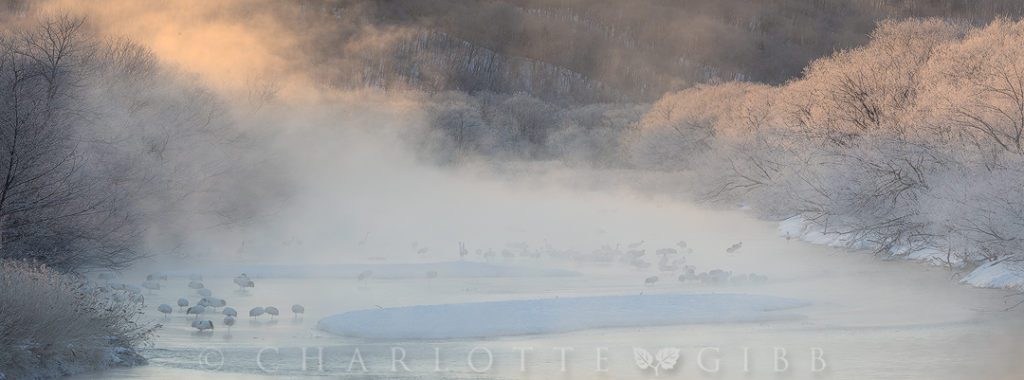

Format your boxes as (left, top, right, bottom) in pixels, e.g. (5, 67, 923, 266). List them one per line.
(0, 260, 154, 379)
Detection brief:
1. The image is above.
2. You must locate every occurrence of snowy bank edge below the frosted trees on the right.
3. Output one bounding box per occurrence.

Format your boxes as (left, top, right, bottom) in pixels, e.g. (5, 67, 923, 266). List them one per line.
(778, 216, 1024, 289)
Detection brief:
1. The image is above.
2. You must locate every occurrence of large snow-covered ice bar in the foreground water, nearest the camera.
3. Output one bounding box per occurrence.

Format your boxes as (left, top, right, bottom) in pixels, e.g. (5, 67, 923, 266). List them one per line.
(318, 294, 808, 340)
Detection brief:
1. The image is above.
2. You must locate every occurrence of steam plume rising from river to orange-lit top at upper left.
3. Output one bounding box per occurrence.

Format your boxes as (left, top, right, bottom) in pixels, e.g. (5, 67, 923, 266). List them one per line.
(25, 1, 712, 268)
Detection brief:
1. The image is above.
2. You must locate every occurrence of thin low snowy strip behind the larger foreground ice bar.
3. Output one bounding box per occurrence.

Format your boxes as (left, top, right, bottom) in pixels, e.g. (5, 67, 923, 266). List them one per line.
(167, 261, 580, 279)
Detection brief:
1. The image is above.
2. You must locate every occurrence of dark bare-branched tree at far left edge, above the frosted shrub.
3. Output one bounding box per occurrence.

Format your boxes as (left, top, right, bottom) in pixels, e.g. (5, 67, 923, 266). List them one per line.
(0, 16, 137, 267)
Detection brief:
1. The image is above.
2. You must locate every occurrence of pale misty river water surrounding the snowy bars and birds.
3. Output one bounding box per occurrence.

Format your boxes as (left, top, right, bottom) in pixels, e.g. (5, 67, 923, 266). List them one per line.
(74, 194, 1024, 380)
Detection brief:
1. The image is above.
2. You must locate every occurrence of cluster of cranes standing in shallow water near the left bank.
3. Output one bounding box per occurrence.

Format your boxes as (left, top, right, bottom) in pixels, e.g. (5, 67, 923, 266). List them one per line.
(142, 273, 306, 332)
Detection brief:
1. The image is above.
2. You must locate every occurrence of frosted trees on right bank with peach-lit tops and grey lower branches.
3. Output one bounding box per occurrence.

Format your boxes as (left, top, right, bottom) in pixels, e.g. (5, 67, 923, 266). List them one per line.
(626, 19, 1024, 263)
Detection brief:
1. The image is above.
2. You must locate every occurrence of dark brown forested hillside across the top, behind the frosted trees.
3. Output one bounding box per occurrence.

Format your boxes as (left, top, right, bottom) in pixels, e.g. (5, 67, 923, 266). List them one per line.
(274, 0, 1024, 103)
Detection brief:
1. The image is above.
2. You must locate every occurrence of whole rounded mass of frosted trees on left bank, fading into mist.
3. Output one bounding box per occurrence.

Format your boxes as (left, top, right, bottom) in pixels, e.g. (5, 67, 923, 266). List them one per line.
(0, 15, 249, 270)
